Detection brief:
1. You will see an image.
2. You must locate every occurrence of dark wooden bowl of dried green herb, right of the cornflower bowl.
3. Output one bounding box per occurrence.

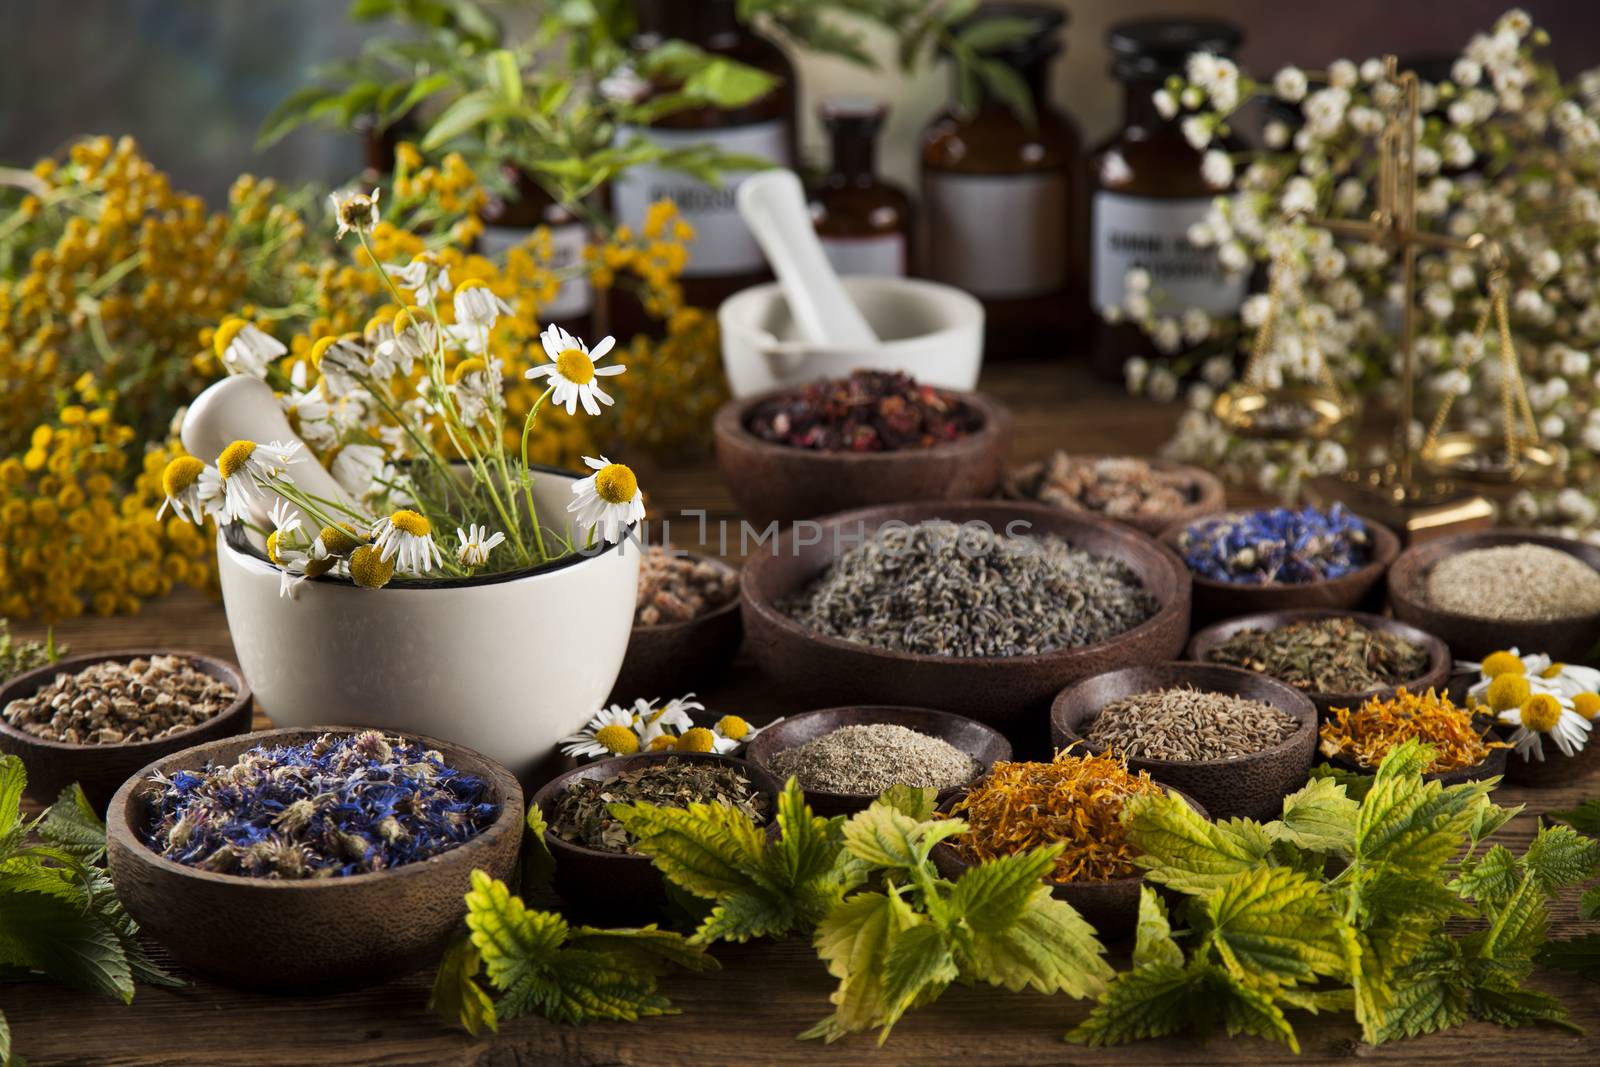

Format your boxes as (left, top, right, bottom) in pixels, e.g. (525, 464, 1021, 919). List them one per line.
(533, 752, 782, 926)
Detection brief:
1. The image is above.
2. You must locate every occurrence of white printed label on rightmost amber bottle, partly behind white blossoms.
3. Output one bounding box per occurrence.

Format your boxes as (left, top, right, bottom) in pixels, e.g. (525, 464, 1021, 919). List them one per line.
(1090, 192, 1248, 315)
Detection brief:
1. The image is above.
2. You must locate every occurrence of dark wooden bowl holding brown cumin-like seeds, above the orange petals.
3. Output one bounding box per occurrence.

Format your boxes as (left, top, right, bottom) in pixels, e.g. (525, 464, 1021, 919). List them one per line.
(1050, 662, 1317, 821)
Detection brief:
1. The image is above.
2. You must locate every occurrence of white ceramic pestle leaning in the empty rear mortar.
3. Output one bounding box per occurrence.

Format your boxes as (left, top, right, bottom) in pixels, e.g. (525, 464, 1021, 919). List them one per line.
(736, 170, 878, 349)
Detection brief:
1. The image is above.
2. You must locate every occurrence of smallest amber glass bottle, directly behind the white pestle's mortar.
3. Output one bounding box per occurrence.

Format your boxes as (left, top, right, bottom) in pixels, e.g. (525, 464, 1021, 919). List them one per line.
(811, 98, 914, 277)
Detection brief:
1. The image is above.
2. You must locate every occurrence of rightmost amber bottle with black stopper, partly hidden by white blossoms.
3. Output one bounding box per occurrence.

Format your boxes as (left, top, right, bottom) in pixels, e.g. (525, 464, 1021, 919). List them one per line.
(1088, 18, 1248, 378)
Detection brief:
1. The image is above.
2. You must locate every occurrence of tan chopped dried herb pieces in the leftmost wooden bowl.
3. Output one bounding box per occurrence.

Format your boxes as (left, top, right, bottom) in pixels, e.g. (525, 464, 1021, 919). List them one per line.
(0, 656, 238, 745)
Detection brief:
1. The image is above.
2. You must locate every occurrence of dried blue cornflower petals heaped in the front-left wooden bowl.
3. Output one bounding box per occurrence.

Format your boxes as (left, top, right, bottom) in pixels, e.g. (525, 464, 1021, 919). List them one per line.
(144, 729, 499, 878)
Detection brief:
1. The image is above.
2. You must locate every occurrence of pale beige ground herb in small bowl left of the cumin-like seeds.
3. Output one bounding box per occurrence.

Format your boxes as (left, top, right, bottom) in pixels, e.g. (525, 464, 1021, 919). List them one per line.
(773, 723, 981, 797)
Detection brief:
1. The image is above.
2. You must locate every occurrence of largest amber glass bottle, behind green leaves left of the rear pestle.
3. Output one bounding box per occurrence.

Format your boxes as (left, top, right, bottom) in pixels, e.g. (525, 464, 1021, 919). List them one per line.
(611, 0, 795, 336)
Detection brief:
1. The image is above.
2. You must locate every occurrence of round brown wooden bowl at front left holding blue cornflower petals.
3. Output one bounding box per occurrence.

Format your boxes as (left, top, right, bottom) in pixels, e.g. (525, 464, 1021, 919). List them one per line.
(107, 726, 523, 992)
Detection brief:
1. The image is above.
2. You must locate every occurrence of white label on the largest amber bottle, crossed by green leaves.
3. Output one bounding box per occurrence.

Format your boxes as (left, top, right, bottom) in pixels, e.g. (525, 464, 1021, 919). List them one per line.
(611, 118, 789, 278)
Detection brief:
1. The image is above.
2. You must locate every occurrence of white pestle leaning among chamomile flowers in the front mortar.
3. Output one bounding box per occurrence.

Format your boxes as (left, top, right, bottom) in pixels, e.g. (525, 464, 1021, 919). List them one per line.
(182, 374, 360, 547)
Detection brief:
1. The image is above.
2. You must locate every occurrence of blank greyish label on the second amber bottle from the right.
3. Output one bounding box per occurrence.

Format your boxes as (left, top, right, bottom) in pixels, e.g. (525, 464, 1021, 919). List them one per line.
(923, 173, 1069, 299)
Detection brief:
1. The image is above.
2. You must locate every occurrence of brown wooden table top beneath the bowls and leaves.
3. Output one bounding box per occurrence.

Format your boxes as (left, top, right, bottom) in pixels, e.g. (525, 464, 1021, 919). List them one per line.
(0, 363, 1600, 1067)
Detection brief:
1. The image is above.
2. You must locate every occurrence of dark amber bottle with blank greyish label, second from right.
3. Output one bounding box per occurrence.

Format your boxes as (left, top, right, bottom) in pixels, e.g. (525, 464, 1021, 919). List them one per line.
(922, 3, 1083, 355)
